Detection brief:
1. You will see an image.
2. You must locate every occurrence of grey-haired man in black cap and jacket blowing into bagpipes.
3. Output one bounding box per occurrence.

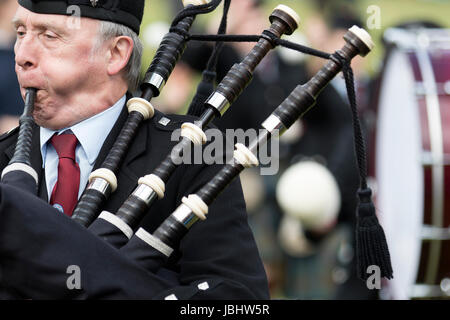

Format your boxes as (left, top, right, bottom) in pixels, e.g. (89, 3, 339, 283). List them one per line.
(0, 0, 268, 299)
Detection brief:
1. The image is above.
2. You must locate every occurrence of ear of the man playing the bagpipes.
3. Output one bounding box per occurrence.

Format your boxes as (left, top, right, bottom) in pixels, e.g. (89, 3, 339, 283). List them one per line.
(108, 36, 134, 76)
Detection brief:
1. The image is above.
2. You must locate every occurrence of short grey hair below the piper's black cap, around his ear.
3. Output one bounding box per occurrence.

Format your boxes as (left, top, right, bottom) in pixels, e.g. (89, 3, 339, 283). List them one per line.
(98, 21, 143, 92)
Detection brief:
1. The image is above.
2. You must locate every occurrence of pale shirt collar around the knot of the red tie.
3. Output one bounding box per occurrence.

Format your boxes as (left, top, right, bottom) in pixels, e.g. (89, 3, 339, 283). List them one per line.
(40, 95, 126, 165)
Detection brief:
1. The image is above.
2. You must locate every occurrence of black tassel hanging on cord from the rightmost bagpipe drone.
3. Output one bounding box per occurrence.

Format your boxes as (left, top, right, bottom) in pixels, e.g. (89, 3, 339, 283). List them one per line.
(356, 188, 393, 280)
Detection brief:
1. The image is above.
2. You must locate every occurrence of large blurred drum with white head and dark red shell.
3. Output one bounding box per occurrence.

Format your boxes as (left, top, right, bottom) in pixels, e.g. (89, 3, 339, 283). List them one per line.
(375, 28, 450, 299)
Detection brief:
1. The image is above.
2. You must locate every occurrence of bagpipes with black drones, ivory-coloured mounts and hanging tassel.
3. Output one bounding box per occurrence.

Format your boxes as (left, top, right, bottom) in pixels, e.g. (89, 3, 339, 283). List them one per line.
(0, 0, 392, 298)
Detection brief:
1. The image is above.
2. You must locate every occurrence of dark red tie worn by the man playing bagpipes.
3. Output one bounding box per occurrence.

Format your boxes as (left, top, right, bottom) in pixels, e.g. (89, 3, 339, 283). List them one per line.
(50, 134, 80, 217)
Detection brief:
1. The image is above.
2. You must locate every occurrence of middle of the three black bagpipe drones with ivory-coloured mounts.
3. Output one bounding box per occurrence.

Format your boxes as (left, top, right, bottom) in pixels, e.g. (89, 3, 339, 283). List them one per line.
(85, 1, 299, 247)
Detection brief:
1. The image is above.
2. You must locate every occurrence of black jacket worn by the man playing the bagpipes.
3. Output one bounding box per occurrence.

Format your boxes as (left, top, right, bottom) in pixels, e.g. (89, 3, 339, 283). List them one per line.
(0, 105, 269, 299)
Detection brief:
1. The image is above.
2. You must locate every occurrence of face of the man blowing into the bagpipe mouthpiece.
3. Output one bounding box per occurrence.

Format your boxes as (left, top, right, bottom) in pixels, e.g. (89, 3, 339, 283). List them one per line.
(13, 7, 107, 129)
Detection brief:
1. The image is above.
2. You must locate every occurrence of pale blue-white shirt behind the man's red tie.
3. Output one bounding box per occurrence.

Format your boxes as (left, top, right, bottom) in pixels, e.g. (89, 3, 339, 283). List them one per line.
(40, 95, 126, 201)
